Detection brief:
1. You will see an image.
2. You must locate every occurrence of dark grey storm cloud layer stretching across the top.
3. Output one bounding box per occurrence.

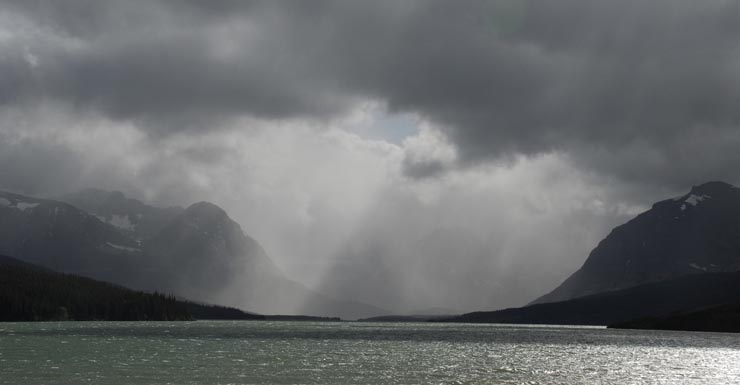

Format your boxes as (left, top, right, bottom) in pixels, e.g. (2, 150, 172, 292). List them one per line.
(0, 0, 740, 184)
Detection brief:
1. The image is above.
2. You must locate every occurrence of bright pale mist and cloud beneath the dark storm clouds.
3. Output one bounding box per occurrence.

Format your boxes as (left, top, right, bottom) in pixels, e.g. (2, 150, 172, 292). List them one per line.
(0, 103, 660, 312)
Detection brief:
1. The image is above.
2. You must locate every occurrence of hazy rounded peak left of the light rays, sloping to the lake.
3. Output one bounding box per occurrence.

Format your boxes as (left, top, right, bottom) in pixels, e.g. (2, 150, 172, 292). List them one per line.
(137, 198, 383, 319)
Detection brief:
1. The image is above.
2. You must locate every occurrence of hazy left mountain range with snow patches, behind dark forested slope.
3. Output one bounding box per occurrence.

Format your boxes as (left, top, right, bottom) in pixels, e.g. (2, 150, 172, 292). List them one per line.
(0, 190, 385, 318)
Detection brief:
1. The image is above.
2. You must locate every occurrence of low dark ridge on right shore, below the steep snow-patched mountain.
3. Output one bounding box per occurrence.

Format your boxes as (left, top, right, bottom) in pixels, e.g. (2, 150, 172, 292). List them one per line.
(441, 272, 740, 325)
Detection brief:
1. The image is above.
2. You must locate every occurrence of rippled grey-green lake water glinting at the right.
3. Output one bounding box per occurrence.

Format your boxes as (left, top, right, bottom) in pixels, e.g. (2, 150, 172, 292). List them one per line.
(0, 321, 740, 385)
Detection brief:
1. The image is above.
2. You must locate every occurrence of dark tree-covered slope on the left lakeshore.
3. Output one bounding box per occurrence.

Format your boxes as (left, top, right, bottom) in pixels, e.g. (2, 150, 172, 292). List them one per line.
(0, 255, 264, 321)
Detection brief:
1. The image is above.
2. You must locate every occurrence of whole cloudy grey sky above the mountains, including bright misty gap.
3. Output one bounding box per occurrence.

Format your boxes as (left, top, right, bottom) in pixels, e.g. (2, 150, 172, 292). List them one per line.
(0, 0, 740, 311)
